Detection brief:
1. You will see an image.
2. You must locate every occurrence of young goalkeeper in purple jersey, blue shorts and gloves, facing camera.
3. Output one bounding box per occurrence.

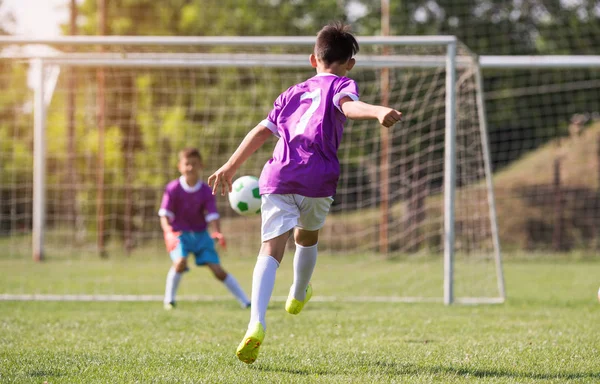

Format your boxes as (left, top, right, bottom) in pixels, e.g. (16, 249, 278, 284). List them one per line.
(158, 148, 250, 309)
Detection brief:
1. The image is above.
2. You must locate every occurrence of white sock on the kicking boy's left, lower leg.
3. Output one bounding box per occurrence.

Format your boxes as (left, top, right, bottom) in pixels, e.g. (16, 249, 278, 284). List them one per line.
(249, 255, 279, 330)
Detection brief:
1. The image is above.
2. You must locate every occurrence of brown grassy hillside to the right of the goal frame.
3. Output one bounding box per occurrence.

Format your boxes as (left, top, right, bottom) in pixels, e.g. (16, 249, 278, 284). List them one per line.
(494, 123, 600, 250)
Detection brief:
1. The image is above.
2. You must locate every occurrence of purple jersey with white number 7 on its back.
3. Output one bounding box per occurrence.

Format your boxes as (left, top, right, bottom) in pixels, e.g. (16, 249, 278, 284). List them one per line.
(259, 73, 358, 197)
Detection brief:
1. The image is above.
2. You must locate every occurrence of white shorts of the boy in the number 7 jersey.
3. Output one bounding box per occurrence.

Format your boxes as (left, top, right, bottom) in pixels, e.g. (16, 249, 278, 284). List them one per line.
(260, 194, 333, 241)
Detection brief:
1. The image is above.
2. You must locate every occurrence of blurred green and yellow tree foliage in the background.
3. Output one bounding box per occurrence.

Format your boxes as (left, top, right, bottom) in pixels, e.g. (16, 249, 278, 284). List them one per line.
(0, 0, 600, 246)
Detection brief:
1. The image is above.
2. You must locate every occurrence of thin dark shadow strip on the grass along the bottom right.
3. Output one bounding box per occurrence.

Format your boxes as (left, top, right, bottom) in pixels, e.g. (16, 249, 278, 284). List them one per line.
(253, 360, 600, 381)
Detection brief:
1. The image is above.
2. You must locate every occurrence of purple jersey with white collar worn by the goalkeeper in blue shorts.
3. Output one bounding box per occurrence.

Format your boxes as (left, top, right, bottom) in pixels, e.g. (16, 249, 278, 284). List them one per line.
(158, 176, 219, 232)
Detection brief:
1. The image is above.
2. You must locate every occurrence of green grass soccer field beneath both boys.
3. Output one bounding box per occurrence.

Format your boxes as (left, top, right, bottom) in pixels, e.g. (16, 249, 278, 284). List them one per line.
(0, 257, 600, 383)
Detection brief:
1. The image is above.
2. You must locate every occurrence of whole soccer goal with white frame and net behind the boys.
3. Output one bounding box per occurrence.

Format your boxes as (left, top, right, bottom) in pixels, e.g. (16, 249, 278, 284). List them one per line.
(0, 36, 505, 304)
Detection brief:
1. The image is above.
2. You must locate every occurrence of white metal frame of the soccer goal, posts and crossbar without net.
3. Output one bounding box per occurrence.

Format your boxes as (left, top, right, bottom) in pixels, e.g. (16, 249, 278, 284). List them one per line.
(0, 36, 508, 304)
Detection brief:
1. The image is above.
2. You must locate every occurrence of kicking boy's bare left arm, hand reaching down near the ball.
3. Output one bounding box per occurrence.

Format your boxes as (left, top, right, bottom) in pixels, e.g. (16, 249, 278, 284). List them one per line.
(208, 124, 273, 196)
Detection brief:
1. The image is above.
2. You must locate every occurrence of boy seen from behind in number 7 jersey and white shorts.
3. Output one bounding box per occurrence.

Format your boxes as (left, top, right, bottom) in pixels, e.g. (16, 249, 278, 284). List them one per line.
(208, 23, 402, 364)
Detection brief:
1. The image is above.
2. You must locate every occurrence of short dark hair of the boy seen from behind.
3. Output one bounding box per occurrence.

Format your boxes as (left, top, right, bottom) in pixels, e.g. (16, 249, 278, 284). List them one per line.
(314, 21, 358, 65)
